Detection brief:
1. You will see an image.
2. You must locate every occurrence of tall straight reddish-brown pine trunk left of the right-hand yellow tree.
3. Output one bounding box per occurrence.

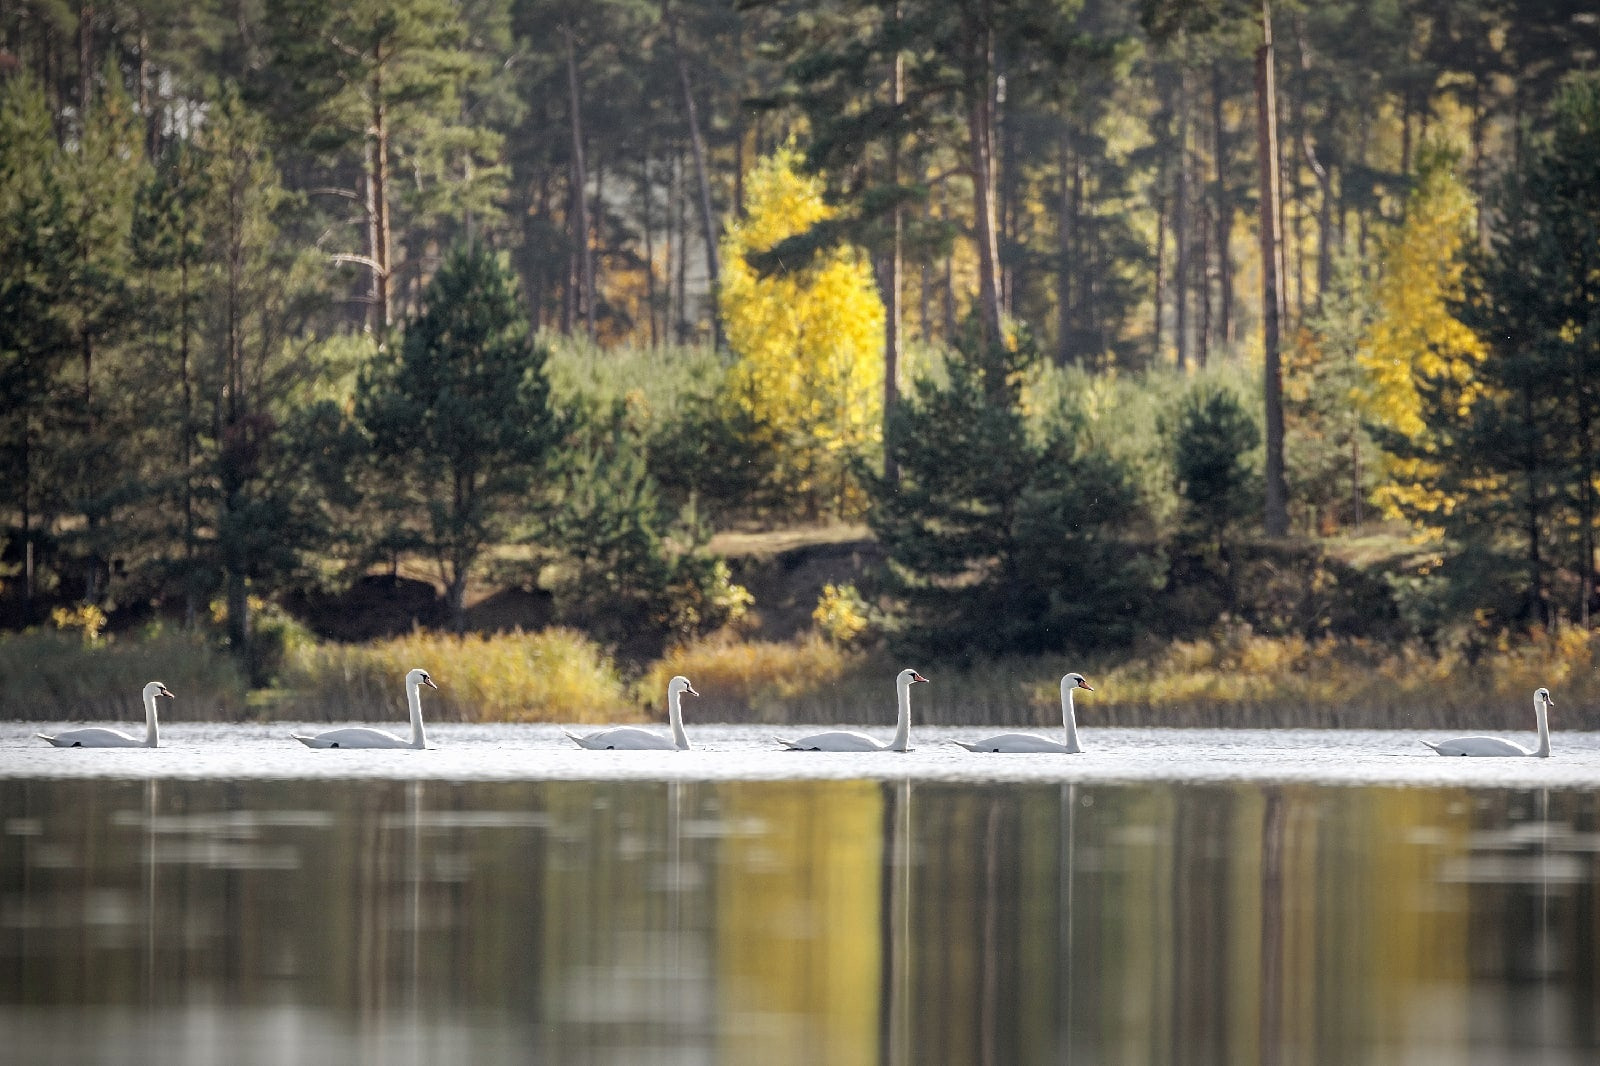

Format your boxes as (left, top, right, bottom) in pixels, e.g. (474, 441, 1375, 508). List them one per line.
(1256, 0, 1290, 536)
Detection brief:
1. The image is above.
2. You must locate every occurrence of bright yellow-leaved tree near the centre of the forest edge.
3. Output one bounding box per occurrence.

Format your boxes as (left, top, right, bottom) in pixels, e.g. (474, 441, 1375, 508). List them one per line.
(720, 149, 883, 517)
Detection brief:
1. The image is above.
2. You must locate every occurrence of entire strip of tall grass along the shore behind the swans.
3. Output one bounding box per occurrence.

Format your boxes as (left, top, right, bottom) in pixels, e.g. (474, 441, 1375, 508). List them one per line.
(0, 626, 1600, 731)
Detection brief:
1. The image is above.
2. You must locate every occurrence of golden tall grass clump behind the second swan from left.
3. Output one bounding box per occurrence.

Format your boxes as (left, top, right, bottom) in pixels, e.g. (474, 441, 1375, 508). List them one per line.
(270, 629, 627, 722)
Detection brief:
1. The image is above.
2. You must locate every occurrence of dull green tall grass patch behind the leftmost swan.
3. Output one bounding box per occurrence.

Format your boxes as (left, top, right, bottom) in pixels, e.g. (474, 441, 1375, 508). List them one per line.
(0, 631, 246, 722)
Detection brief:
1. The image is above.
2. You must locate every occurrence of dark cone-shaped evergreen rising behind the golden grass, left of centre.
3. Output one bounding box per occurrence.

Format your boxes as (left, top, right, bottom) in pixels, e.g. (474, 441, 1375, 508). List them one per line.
(358, 243, 558, 629)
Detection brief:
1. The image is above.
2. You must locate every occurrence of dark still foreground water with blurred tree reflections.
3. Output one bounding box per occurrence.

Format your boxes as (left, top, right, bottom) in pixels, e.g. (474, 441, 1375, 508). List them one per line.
(0, 781, 1600, 1066)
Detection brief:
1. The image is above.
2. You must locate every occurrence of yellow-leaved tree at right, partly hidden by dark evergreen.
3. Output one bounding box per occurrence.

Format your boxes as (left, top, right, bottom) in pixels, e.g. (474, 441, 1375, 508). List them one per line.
(1358, 146, 1483, 515)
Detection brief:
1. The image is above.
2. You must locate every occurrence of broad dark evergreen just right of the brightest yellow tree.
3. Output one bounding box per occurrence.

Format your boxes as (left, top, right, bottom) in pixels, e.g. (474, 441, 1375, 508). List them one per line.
(869, 323, 1157, 659)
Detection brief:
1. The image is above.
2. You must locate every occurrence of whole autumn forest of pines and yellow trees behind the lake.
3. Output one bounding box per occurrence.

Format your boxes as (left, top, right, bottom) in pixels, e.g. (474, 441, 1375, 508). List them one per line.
(0, 0, 1600, 720)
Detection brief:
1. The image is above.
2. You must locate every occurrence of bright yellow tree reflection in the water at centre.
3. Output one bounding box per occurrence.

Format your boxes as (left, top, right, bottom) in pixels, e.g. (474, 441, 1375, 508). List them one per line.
(717, 781, 883, 1066)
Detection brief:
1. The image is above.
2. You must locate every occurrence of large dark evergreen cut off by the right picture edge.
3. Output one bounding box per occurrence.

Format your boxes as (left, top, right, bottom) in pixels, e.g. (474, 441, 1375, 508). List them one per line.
(1395, 75, 1600, 626)
